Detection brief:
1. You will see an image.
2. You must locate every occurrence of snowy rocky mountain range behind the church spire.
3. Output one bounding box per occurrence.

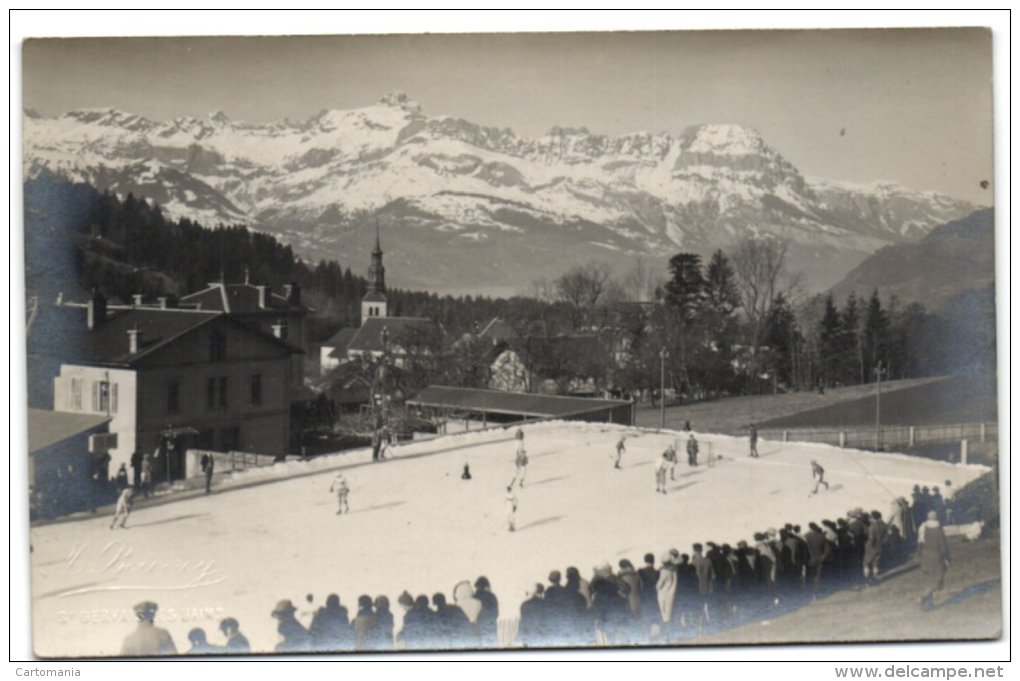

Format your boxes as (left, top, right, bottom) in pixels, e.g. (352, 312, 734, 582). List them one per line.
(23, 94, 976, 295)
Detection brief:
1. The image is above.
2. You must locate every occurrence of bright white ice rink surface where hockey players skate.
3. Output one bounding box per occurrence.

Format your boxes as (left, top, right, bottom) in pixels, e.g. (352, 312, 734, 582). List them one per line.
(31, 423, 985, 657)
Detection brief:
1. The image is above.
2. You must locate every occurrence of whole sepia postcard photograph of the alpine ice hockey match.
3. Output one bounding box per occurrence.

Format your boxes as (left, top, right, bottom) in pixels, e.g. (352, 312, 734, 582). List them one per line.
(11, 13, 1009, 661)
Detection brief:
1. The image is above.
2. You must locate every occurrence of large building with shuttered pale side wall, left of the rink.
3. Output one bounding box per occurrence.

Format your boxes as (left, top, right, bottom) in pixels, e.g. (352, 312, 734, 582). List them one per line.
(29, 295, 302, 482)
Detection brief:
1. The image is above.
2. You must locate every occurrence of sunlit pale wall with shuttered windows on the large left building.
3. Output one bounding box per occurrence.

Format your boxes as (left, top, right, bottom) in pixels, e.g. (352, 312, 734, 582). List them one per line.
(53, 364, 138, 471)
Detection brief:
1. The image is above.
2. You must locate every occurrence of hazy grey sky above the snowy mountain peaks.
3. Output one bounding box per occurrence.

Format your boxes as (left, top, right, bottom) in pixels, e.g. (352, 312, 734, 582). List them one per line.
(22, 29, 992, 204)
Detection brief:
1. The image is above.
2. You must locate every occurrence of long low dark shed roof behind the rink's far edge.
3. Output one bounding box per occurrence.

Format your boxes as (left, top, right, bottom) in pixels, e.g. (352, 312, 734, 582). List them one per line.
(408, 385, 630, 418)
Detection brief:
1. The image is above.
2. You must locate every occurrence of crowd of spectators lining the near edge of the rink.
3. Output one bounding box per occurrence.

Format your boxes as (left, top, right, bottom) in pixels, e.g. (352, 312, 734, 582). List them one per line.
(124, 486, 952, 654)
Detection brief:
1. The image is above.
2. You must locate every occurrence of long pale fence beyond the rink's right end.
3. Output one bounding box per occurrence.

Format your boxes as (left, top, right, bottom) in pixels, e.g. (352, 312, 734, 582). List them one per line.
(759, 423, 999, 449)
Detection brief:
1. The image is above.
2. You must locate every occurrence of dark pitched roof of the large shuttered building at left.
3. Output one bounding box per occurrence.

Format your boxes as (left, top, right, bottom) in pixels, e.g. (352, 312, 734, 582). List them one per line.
(29, 306, 302, 366)
